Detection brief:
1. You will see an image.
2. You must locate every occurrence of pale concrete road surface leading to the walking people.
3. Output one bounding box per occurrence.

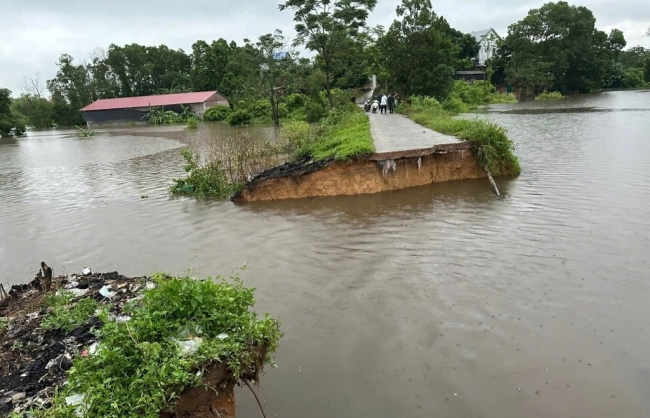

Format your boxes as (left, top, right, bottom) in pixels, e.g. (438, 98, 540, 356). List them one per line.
(368, 108, 458, 153)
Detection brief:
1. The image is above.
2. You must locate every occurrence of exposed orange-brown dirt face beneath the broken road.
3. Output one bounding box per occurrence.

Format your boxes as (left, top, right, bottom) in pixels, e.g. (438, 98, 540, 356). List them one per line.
(233, 142, 480, 202)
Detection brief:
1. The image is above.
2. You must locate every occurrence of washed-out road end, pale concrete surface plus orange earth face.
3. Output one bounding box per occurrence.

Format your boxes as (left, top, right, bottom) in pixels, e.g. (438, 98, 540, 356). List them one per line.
(233, 108, 496, 202)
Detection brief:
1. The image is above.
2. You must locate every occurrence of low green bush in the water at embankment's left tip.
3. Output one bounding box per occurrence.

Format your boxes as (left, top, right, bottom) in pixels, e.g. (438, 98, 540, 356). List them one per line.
(170, 148, 238, 199)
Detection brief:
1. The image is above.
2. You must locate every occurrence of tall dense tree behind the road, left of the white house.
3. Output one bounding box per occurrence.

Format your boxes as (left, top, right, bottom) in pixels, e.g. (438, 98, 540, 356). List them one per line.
(379, 0, 461, 100)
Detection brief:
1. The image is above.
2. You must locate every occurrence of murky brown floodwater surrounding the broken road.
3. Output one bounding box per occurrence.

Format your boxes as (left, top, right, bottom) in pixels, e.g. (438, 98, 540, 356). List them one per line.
(0, 92, 650, 418)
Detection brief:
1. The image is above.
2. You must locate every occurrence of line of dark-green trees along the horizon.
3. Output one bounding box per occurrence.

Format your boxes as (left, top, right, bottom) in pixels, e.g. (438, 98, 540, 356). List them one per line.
(0, 0, 650, 134)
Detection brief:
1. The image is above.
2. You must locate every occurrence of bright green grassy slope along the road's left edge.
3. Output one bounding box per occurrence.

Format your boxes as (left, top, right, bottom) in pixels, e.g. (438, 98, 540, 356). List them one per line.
(297, 104, 375, 160)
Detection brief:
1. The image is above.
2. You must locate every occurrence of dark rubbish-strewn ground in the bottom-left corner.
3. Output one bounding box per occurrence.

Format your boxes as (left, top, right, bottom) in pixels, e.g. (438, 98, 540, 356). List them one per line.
(0, 263, 148, 416)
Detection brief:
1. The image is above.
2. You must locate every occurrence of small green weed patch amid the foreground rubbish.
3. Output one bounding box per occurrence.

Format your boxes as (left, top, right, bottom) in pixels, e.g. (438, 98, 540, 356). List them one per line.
(41, 292, 99, 332)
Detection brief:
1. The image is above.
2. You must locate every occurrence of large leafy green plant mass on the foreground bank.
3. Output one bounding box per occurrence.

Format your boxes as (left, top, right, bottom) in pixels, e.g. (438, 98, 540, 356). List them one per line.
(42, 274, 281, 418)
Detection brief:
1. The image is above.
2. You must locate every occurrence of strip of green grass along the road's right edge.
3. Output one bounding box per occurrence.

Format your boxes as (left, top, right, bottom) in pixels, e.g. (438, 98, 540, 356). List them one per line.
(398, 97, 521, 176)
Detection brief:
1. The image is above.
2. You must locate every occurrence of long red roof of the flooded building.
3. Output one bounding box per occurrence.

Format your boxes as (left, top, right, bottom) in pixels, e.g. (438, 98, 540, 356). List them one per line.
(81, 91, 226, 112)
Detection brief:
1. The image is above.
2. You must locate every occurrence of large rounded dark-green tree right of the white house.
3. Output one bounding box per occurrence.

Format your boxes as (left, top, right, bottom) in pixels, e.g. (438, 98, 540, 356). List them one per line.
(502, 1, 612, 93)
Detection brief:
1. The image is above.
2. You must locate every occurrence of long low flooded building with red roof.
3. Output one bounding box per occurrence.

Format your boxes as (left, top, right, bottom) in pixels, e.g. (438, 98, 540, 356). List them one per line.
(80, 91, 228, 128)
